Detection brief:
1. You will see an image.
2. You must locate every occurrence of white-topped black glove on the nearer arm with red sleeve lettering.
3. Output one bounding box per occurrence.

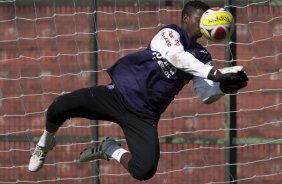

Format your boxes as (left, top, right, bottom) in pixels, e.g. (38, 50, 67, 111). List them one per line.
(208, 66, 243, 82)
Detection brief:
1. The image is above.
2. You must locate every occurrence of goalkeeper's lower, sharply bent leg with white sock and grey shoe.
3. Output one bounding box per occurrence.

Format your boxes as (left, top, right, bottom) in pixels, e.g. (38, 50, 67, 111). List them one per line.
(79, 113, 160, 180)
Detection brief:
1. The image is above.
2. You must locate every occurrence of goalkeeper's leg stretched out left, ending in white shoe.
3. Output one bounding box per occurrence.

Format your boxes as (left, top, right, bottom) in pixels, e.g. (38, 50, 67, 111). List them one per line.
(29, 86, 123, 172)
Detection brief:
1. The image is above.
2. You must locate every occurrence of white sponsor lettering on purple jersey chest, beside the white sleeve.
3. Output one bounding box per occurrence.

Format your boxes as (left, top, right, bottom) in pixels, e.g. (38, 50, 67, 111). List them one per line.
(152, 52, 177, 78)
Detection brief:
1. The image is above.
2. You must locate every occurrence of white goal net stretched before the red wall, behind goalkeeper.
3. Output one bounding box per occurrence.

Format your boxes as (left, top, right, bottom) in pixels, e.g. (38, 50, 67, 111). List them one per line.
(0, 0, 282, 184)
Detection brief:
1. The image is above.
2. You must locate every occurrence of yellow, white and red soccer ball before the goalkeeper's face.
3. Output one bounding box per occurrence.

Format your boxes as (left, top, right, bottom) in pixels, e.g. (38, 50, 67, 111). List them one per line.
(200, 7, 235, 42)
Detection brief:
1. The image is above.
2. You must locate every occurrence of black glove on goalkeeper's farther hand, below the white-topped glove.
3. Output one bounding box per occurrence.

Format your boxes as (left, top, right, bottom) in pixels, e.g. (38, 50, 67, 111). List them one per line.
(219, 71, 248, 94)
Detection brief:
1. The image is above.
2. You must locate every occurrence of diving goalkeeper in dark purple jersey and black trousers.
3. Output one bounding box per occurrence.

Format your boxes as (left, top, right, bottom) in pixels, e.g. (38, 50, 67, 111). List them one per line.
(29, 1, 248, 180)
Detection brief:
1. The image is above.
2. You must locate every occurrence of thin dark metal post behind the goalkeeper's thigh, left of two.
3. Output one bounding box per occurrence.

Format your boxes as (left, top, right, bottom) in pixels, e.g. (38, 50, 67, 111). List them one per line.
(89, 0, 100, 184)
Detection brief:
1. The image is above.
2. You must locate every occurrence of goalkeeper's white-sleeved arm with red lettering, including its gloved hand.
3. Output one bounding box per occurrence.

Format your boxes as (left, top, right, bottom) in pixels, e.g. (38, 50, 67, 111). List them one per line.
(150, 28, 247, 82)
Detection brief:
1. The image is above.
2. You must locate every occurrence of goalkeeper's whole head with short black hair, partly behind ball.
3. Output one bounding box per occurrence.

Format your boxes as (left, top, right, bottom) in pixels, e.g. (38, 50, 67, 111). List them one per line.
(181, 0, 210, 40)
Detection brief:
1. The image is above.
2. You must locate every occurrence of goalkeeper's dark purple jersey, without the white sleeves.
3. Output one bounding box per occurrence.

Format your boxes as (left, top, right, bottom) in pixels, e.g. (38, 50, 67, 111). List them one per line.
(108, 25, 211, 118)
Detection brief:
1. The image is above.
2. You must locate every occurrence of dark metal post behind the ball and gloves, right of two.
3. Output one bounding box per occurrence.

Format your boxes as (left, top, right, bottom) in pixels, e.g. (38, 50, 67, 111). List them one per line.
(224, 0, 237, 183)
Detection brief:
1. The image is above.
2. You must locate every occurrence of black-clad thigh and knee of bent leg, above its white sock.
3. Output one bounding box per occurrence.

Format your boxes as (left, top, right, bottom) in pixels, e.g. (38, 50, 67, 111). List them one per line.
(121, 118, 160, 180)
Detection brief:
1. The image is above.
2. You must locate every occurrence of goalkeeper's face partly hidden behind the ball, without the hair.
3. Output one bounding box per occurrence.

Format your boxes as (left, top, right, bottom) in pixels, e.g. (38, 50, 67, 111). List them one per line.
(183, 10, 204, 39)
